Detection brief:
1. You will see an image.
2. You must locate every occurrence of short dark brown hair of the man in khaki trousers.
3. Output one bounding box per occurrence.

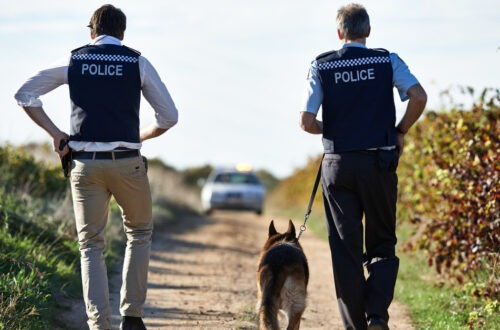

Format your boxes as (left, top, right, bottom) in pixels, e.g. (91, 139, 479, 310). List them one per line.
(88, 5, 127, 38)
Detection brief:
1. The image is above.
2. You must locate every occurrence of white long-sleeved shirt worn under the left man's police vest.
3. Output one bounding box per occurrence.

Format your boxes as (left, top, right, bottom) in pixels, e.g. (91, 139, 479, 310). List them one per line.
(14, 35, 178, 151)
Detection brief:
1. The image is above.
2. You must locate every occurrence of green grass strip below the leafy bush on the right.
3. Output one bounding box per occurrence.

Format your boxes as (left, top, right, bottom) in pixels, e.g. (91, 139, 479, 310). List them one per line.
(395, 224, 500, 330)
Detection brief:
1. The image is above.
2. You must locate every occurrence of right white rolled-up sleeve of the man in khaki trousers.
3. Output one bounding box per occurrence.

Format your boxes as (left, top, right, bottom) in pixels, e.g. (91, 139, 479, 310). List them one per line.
(139, 56, 179, 129)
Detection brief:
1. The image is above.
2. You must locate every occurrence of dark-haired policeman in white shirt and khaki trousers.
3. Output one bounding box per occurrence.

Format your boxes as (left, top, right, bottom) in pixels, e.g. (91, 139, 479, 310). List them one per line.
(15, 5, 178, 329)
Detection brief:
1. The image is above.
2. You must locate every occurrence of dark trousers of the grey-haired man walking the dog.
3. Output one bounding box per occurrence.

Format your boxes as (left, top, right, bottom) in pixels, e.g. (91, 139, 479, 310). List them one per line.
(322, 150, 399, 330)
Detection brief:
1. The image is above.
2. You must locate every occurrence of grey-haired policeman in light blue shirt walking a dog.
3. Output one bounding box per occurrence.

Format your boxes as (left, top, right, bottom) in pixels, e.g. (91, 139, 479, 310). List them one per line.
(300, 4, 427, 330)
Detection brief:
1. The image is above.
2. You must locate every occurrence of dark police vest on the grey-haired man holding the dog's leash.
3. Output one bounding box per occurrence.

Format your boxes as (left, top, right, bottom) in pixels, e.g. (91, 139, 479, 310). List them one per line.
(316, 47, 397, 153)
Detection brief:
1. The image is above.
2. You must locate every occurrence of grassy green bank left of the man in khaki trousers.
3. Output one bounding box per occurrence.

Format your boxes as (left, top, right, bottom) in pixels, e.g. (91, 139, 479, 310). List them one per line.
(0, 146, 81, 329)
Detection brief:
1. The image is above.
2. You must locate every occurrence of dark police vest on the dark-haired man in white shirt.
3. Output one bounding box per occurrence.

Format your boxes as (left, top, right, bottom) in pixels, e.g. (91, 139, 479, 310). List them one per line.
(68, 44, 141, 143)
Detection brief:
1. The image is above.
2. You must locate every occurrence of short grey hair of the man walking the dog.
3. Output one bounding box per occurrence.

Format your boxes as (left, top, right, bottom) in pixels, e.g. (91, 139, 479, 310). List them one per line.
(337, 3, 370, 40)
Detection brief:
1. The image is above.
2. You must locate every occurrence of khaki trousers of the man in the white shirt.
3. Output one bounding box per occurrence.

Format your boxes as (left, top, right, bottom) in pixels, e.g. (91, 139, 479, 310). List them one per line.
(71, 156, 153, 329)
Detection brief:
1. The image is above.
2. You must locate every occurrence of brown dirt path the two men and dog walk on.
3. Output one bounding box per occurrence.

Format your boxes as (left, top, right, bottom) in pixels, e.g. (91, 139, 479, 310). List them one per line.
(56, 212, 412, 330)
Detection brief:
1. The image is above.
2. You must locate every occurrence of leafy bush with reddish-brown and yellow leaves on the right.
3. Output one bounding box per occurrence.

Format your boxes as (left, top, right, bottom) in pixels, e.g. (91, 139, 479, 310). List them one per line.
(398, 89, 500, 299)
